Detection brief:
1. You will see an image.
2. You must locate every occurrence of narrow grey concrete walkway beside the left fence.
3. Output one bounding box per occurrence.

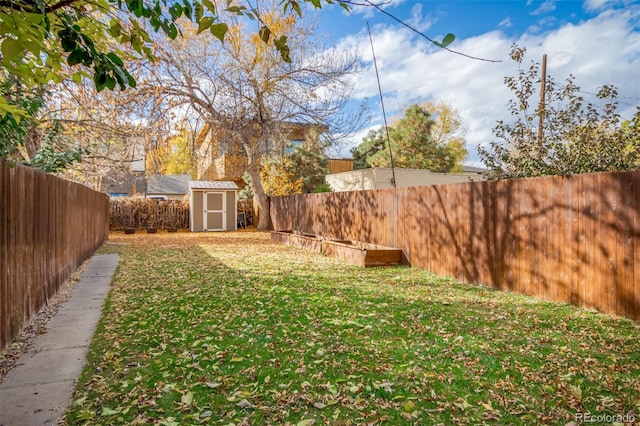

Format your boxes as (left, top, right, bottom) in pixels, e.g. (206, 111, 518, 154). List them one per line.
(0, 254, 118, 426)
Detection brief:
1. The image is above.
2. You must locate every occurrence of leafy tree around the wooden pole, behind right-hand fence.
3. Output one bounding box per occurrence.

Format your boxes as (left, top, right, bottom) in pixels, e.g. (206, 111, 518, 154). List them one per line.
(478, 45, 640, 179)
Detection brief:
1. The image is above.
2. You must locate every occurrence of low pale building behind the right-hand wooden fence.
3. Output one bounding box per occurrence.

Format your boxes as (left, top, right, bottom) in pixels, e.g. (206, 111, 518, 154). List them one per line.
(325, 168, 485, 192)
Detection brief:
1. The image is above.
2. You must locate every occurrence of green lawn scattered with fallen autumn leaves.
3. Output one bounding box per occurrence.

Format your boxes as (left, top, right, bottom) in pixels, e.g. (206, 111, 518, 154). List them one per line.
(66, 232, 640, 425)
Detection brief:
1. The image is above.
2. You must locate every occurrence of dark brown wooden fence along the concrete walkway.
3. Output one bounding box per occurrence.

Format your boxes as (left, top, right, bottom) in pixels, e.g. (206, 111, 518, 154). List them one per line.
(0, 159, 109, 350)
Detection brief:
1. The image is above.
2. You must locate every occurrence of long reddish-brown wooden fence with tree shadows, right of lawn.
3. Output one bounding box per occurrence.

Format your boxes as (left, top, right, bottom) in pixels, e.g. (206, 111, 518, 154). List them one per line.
(271, 171, 640, 319)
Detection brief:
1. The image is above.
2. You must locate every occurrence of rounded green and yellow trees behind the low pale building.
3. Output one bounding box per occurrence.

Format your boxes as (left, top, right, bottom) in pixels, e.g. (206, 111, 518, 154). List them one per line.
(351, 103, 467, 172)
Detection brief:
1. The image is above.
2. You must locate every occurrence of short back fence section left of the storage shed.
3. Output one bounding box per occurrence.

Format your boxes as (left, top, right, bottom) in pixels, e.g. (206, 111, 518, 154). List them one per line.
(109, 197, 189, 230)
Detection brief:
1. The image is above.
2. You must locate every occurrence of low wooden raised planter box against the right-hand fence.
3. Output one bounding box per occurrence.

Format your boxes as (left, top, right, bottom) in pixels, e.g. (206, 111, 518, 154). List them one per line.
(322, 240, 402, 267)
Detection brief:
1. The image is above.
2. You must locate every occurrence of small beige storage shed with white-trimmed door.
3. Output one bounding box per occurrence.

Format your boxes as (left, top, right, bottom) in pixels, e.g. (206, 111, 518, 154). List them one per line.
(189, 180, 238, 232)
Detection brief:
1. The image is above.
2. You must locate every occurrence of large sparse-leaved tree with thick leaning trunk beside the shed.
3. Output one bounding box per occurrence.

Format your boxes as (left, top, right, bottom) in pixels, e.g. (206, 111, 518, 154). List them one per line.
(143, 2, 360, 229)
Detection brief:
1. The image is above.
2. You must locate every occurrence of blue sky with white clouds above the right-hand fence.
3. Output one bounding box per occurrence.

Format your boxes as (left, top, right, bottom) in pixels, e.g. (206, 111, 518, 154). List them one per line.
(308, 0, 640, 165)
